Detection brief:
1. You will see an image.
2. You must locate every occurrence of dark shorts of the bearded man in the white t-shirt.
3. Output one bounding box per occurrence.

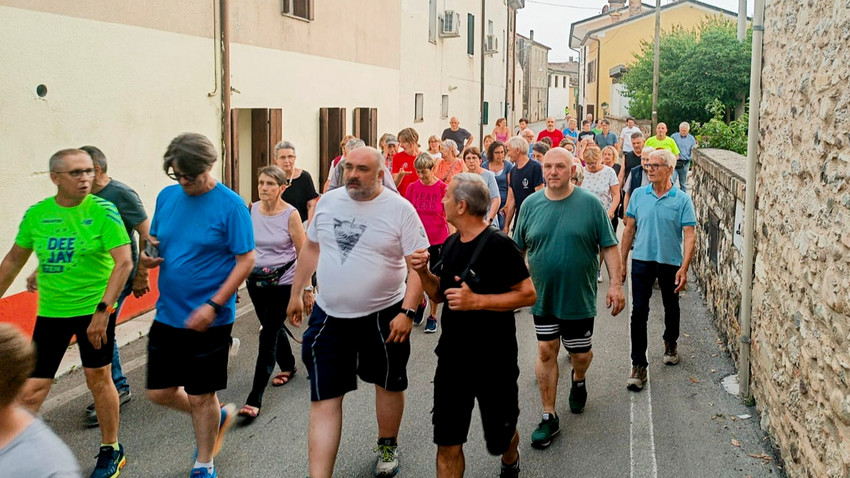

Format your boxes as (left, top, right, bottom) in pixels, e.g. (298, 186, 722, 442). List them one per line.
(301, 302, 410, 402)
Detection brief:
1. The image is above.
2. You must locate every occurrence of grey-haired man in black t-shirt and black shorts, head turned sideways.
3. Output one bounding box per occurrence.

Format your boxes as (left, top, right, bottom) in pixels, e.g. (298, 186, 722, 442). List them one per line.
(411, 173, 537, 476)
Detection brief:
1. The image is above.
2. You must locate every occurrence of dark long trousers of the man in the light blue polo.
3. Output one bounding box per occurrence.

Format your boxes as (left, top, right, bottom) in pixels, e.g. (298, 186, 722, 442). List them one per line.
(630, 259, 680, 367)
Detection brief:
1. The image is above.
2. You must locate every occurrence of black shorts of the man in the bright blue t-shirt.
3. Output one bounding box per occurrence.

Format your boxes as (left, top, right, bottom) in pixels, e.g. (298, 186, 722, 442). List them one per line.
(147, 321, 233, 395)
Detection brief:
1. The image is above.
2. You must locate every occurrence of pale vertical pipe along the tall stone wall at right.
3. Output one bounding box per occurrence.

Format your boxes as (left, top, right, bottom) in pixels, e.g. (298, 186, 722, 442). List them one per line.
(738, 0, 764, 401)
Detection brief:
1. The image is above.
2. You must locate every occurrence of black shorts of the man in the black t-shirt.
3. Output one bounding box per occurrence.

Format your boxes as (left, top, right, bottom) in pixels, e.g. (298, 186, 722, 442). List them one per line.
(432, 355, 519, 455)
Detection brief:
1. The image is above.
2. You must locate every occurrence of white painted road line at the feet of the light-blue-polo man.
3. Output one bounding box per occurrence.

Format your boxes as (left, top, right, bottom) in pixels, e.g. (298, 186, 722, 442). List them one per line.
(624, 265, 658, 478)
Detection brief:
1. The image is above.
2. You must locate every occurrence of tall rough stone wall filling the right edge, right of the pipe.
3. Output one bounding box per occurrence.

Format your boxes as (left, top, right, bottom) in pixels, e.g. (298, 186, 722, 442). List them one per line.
(752, 0, 850, 477)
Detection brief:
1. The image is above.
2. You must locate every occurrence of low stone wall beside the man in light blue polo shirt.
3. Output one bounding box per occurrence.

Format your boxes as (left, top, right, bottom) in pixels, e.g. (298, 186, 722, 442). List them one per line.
(688, 149, 746, 359)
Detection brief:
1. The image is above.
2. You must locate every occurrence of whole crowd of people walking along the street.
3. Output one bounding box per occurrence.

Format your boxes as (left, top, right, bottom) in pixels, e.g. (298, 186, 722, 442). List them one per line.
(0, 115, 696, 478)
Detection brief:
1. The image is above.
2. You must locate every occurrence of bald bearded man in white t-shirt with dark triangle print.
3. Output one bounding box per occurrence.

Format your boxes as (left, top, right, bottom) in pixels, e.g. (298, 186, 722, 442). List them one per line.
(287, 147, 429, 477)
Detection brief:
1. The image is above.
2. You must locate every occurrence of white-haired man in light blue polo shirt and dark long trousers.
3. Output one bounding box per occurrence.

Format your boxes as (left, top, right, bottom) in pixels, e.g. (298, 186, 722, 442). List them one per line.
(621, 149, 697, 392)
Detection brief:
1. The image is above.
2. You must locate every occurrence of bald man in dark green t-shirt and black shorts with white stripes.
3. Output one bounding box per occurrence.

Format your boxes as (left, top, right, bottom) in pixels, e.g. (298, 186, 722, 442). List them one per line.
(514, 148, 625, 448)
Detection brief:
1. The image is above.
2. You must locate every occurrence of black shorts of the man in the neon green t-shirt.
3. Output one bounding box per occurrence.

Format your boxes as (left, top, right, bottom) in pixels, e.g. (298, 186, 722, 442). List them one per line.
(30, 313, 116, 379)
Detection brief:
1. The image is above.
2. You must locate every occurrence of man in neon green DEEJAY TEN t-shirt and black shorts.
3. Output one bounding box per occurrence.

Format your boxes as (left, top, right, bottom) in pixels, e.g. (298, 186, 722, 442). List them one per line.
(0, 149, 133, 478)
